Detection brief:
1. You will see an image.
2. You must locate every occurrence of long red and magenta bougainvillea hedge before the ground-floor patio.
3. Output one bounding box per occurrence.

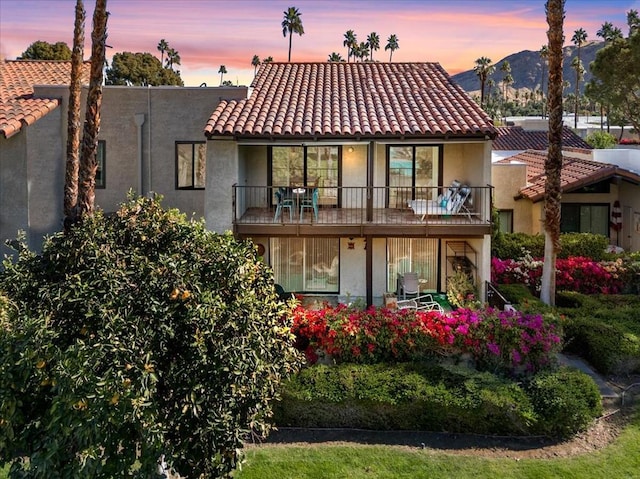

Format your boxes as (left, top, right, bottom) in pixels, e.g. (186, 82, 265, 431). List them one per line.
(292, 305, 560, 372)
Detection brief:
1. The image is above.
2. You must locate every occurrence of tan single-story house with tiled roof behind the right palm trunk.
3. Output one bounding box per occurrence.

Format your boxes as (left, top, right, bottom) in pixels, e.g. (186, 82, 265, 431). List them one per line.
(492, 149, 640, 251)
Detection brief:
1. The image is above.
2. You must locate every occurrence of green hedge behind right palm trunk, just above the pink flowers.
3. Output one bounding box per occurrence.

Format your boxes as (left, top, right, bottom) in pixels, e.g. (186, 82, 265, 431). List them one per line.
(492, 233, 609, 261)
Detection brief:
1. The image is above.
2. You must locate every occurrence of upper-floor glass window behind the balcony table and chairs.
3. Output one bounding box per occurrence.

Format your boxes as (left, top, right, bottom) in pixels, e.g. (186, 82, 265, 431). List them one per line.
(270, 146, 341, 206)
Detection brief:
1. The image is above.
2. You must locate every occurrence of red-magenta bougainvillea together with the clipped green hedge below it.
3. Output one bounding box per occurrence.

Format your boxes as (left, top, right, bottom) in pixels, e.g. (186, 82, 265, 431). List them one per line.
(274, 305, 602, 437)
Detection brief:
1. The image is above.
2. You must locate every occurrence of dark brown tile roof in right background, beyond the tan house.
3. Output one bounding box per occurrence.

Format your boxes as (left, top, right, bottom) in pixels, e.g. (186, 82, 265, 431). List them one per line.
(493, 126, 592, 151)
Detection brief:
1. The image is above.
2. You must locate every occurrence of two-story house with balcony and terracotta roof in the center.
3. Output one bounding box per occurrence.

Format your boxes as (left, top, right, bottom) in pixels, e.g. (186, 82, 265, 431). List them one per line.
(205, 62, 496, 304)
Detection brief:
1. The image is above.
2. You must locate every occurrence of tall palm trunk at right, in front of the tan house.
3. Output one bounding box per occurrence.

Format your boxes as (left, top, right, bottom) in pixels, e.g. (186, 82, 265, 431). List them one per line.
(540, 0, 564, 305)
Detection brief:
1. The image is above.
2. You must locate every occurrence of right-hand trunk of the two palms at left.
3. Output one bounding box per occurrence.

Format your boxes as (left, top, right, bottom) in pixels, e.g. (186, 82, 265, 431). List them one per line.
(78, 0, 109, 219)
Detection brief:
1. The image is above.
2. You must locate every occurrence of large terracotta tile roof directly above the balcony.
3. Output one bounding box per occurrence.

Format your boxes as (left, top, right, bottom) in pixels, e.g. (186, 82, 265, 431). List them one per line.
(205, 62, 496, 138)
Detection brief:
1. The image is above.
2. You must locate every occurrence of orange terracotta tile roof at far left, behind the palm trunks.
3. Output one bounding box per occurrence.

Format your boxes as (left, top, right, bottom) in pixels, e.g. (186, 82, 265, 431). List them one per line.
(0, 60, 90, 138)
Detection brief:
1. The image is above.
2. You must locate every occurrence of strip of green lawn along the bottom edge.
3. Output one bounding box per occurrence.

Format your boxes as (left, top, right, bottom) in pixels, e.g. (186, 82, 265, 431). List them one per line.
(234, 410, 640, 479)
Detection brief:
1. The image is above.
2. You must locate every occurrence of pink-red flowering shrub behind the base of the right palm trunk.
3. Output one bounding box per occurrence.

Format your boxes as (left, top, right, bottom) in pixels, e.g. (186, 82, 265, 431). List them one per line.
(491, 256, 624, 294)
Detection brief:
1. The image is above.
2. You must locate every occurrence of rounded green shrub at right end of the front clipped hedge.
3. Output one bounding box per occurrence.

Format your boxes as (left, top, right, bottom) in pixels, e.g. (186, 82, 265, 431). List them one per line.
(526, 368, 602, 438)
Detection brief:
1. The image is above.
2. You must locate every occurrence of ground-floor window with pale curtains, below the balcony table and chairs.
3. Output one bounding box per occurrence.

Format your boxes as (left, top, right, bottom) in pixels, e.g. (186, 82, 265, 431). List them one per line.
(270, 238, 340, 293)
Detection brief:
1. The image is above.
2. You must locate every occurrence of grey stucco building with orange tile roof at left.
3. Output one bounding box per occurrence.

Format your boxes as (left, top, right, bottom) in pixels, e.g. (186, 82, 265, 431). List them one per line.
(0, 60, 247, 253)
